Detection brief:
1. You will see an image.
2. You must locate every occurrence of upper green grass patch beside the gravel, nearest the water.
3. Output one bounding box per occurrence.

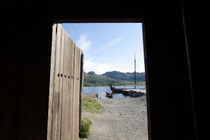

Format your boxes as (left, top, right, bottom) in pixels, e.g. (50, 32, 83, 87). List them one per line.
(82, 97, 102, 113)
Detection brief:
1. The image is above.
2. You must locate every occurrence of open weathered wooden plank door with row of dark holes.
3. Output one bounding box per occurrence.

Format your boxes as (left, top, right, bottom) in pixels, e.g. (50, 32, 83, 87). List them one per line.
(47, 24, 82, 140)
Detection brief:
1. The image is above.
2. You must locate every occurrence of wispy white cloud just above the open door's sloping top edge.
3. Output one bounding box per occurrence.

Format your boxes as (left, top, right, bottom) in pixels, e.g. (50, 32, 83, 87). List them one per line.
(76, 34, 91, 54)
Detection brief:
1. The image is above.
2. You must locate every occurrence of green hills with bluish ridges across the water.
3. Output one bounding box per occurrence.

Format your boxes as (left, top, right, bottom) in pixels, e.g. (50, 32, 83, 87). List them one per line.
(84, 71, 145, 86)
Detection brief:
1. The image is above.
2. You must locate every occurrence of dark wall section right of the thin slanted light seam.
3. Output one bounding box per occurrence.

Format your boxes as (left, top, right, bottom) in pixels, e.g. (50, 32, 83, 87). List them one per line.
(181, 2, 210, 139)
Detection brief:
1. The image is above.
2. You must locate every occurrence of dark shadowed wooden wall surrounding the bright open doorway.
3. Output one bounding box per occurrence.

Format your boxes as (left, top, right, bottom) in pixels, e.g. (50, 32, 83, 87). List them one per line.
(0, 0, 209, 140)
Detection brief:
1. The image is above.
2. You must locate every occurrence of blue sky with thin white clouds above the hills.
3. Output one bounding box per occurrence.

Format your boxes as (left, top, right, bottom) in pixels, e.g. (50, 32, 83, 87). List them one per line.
(62, 23, 145, 74)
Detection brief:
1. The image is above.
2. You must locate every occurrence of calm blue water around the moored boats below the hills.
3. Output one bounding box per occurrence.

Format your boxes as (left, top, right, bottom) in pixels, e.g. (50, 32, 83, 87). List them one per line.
(82, 85, 145, 99)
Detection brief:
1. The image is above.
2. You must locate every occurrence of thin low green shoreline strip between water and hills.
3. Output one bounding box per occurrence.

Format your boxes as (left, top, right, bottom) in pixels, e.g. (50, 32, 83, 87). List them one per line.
(84, 82, 145, 87)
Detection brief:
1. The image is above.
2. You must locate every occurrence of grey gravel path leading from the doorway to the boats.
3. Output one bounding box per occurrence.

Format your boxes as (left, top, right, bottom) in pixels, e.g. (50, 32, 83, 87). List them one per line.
(82, 96, 148, 140)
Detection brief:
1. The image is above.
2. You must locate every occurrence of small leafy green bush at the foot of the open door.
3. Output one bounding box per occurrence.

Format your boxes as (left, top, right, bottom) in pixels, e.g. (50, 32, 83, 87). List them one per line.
(79, 118, 92, 140)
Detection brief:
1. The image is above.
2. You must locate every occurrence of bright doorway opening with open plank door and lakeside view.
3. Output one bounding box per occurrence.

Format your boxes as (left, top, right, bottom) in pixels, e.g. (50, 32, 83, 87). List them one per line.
(48, 22, 148, 140)
